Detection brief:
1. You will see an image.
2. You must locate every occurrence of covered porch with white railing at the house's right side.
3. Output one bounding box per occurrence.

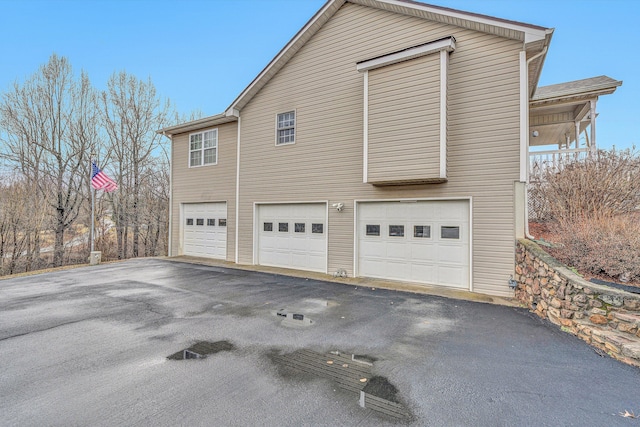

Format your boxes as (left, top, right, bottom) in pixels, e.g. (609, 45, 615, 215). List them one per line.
(528, 76, 622, 181)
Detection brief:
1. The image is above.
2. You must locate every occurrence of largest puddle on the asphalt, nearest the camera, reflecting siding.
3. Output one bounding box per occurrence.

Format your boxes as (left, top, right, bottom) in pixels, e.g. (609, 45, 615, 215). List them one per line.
(272, 349, 412, 421)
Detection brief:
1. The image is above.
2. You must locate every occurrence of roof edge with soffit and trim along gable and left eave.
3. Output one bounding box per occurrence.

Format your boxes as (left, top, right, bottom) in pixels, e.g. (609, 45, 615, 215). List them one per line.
(159, 0, 553, 135)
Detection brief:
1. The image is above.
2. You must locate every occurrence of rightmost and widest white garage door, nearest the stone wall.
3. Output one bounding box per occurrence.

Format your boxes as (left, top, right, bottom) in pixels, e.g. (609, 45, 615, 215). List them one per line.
(357, 200, 470, 289)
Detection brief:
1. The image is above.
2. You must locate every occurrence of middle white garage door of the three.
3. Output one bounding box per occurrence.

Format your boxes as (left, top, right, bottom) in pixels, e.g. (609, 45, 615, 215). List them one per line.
(256, 203, 327, 273)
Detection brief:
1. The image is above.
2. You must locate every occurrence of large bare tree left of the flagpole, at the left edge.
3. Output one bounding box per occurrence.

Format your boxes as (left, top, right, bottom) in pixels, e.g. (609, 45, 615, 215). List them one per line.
(0, 54, 98, 266)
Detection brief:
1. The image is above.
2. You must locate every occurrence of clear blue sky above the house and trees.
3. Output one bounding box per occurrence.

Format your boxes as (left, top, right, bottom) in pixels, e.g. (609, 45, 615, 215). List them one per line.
(0, 0, 640, 148)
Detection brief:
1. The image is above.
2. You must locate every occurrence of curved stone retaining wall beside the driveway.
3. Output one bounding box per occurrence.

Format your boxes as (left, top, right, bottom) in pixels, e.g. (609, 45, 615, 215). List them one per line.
(515, 239, 640, 367)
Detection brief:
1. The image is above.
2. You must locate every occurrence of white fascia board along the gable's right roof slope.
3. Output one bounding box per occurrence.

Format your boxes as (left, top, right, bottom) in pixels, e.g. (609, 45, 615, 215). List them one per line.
(377, 0, 547, 43)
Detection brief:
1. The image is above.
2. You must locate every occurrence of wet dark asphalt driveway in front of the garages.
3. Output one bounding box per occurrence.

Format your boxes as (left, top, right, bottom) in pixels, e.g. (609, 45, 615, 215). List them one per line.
(0, 259, 640, 426)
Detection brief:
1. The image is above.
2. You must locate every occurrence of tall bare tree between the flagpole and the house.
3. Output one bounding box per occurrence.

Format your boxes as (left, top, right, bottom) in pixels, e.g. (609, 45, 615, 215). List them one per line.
(102, 72, 169, 259)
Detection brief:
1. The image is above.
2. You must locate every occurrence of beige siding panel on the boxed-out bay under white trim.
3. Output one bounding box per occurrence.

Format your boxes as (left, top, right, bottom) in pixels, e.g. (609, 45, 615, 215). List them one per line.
(367, 53, 440, 183)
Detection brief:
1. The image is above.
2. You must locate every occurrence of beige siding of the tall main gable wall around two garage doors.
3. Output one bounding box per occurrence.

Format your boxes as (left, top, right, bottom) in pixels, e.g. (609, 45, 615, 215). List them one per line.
(239, 3, 522, 295)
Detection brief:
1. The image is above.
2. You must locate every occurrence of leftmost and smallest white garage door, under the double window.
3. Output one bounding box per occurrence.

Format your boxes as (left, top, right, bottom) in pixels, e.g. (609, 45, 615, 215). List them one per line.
(182, 202, 227, 259)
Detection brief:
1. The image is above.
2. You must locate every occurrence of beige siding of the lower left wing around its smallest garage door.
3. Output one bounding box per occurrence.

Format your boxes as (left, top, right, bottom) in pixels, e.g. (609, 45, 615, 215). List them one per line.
(169, 122, 238, 261)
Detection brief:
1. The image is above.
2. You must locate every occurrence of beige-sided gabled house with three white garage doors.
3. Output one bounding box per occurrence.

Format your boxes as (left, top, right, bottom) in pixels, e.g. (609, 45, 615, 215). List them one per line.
(160, 0, 619, 296)
